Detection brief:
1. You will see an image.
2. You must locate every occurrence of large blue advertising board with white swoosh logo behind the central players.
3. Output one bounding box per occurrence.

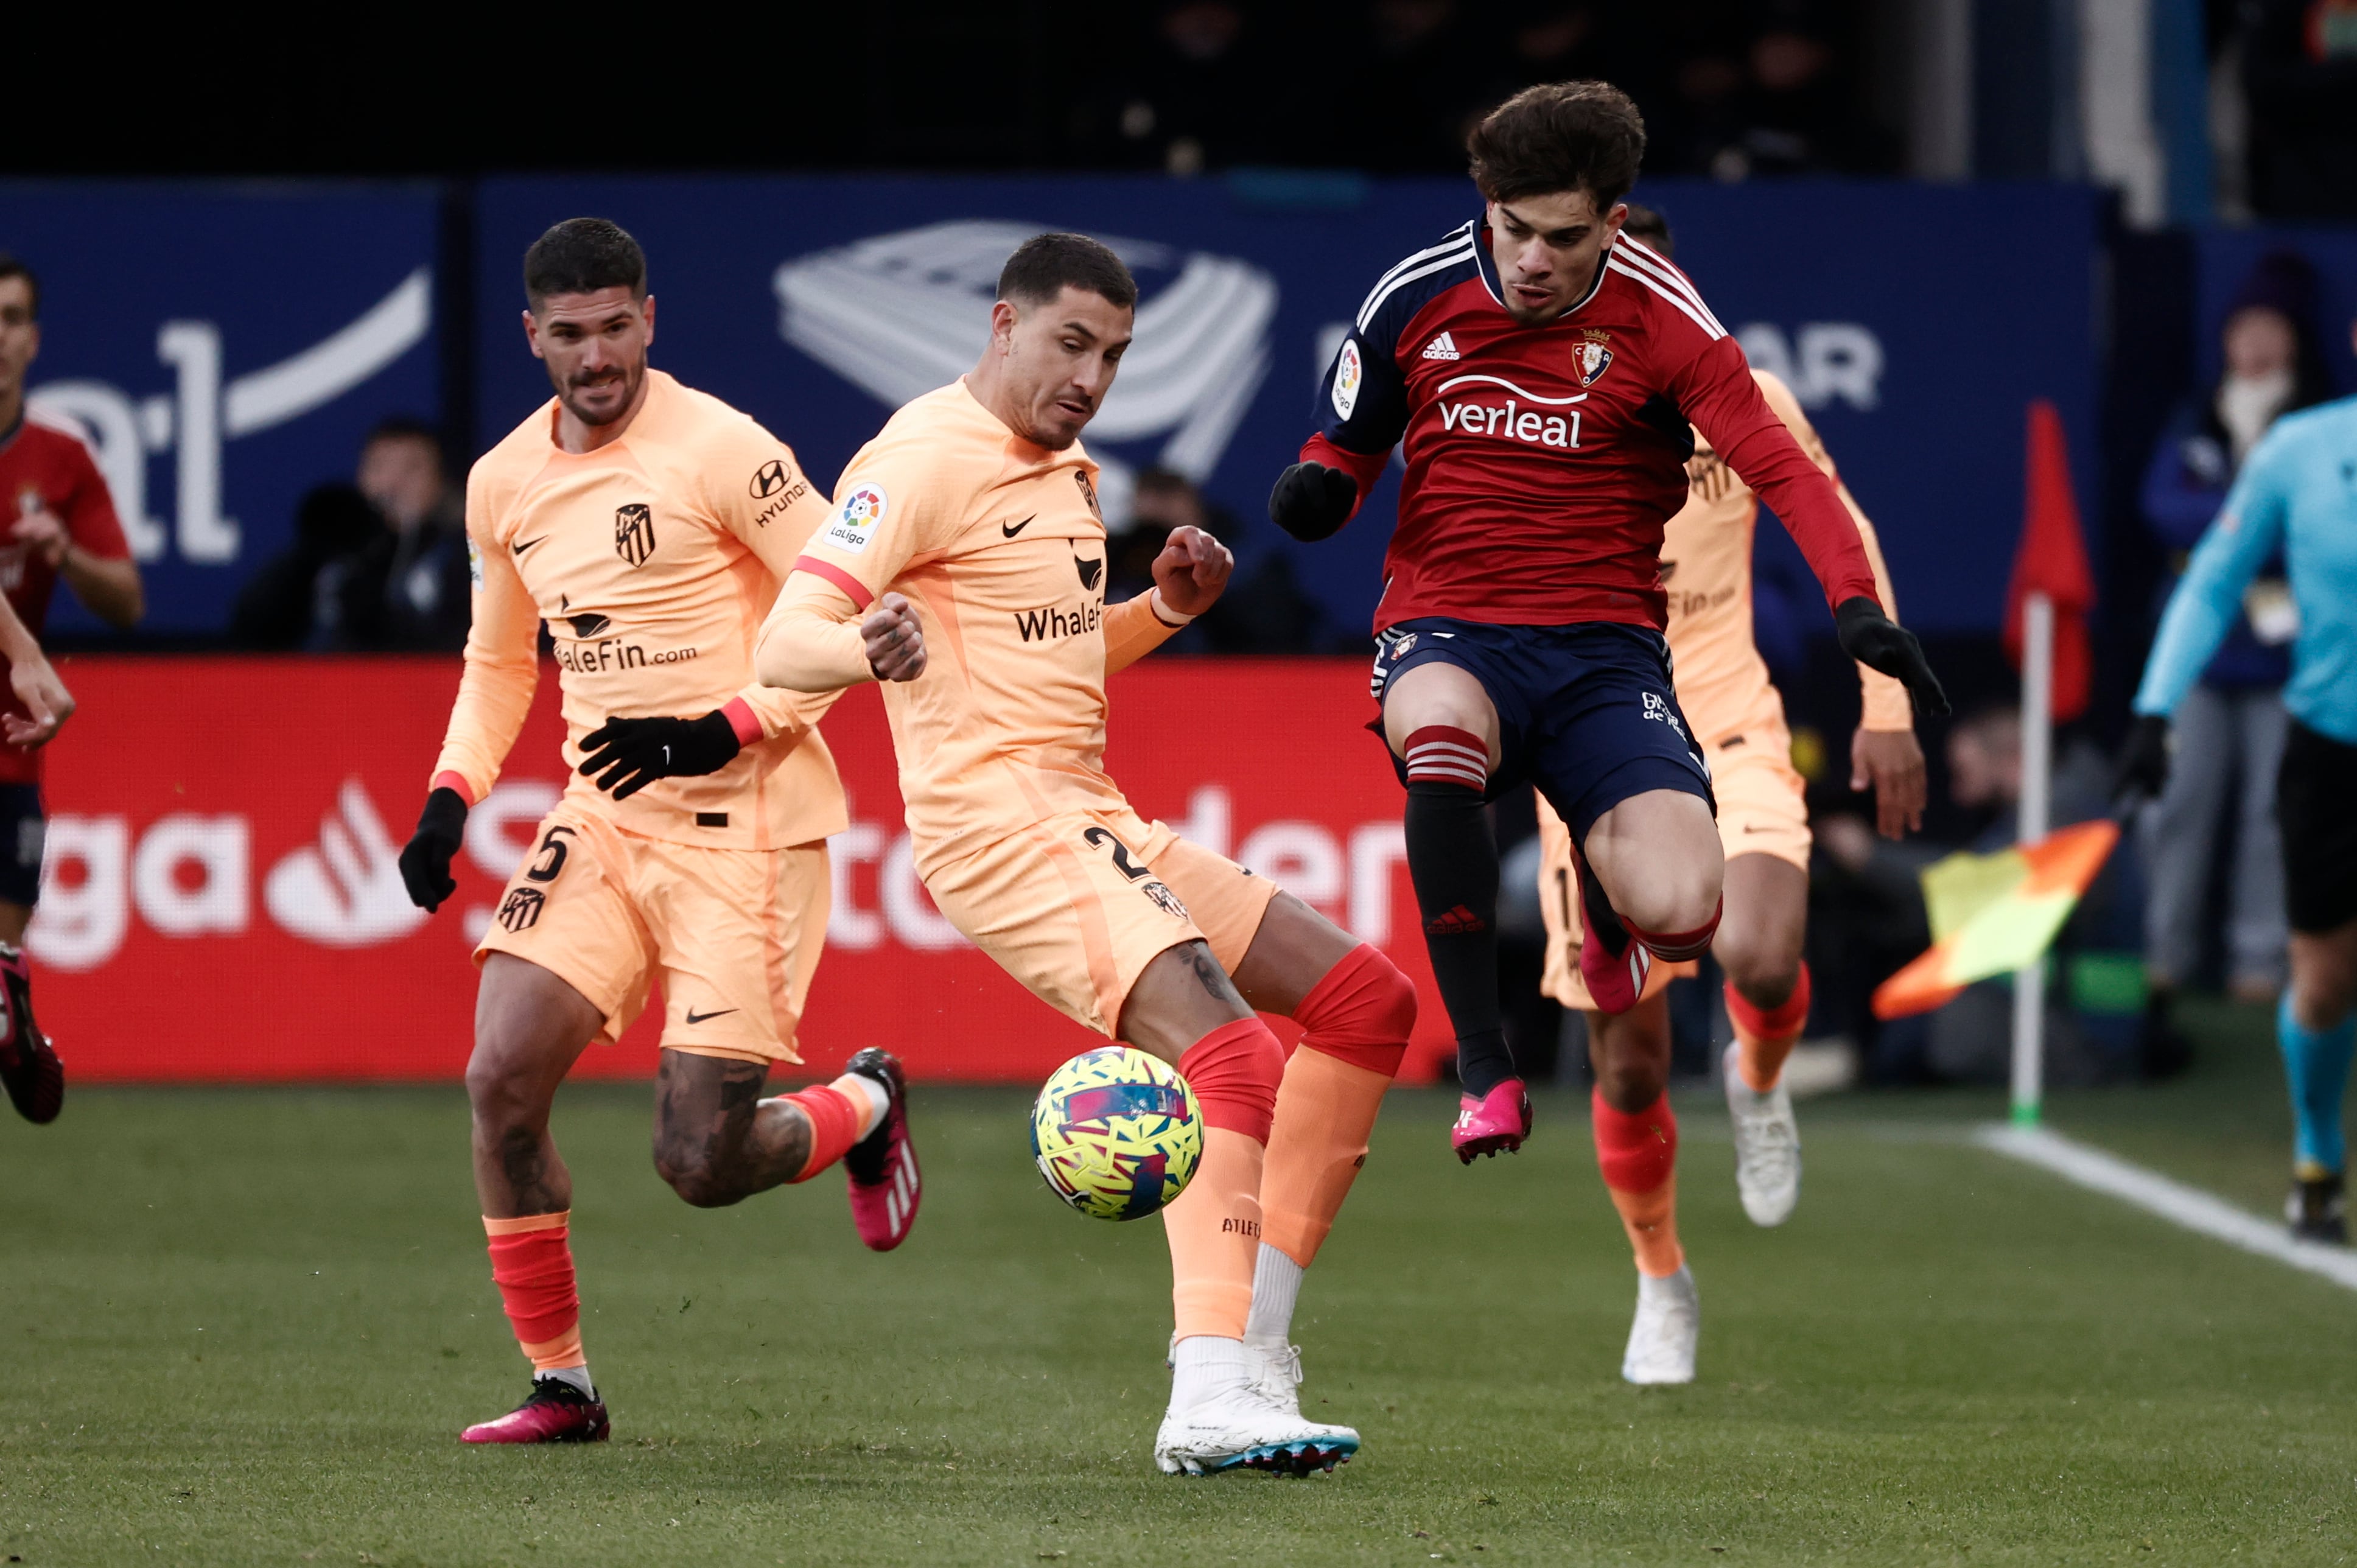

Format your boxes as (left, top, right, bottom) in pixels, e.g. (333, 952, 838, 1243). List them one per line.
(476, 175, 2100, 632)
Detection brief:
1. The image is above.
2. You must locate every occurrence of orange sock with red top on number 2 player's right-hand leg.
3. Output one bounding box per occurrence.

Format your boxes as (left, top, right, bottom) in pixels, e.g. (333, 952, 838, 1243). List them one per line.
(1261, 945, 1417, 1269)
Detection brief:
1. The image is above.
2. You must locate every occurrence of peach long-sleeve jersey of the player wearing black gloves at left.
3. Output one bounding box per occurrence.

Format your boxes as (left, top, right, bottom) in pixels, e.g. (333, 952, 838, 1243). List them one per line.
(433, 370, 846, 849)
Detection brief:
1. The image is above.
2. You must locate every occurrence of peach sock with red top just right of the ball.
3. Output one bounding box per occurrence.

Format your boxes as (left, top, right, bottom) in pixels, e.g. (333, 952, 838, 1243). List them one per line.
(1162, 1018, 1284, 1339)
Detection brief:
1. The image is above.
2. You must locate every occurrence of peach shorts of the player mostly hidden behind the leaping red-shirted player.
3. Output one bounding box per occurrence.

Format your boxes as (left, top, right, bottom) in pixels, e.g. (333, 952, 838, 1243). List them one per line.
(1539, 724, 1810, 1009)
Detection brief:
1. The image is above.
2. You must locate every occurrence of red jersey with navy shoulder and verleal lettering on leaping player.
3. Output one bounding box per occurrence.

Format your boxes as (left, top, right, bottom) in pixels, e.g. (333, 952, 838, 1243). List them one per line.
(1301, 219, 1874, 629)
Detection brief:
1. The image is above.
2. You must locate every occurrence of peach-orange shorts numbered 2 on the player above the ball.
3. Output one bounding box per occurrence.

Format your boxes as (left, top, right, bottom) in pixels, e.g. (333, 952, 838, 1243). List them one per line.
(924, 811, 1278, 1035)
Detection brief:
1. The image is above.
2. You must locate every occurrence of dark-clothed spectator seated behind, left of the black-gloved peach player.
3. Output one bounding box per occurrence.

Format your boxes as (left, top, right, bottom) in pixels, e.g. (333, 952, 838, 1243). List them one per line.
(229, 415, 471, 653)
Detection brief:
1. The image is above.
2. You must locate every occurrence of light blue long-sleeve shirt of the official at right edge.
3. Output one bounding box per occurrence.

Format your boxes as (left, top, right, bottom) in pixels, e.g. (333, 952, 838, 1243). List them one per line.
(2135, 399, 2357, 745)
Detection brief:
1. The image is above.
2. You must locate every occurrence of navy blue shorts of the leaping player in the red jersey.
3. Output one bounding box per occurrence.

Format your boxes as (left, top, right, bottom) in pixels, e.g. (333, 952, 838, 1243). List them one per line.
(1372, 615, 1718, 844)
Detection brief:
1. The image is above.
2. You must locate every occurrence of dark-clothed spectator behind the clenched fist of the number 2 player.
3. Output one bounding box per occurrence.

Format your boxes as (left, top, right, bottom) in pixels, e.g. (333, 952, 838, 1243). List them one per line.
(1105, 469, 1334, 653)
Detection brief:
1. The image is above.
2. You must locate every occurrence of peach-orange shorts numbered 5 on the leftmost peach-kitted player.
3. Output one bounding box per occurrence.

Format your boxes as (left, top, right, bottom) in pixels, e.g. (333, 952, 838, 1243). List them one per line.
(474, 804, 830, 1061)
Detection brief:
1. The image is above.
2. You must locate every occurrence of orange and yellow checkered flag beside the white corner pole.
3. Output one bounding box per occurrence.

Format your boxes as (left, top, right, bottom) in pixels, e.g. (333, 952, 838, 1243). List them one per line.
(1874, 818, 2119, 1018)
